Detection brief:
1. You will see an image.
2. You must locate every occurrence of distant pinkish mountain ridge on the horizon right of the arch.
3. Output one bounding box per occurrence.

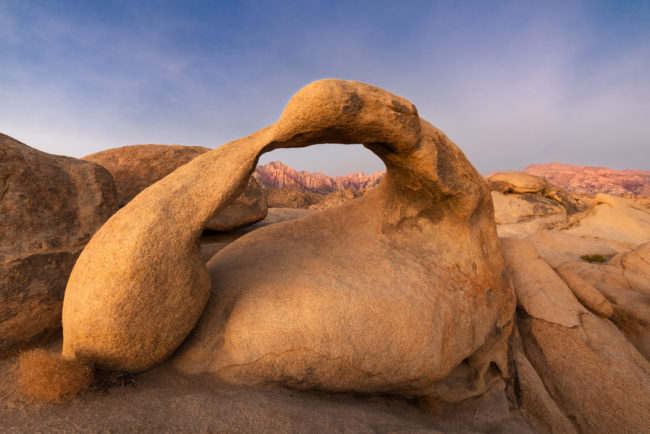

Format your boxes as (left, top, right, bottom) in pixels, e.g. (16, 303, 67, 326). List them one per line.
(524, 163, 650, 196)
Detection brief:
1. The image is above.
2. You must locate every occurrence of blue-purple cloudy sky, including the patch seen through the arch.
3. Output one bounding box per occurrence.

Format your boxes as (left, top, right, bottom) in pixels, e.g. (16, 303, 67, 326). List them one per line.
(0, 0, 650, 175)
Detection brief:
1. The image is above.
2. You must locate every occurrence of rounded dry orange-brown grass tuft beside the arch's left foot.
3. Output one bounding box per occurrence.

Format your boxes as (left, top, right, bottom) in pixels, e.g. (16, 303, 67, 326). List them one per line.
(16, 349, 94, 403)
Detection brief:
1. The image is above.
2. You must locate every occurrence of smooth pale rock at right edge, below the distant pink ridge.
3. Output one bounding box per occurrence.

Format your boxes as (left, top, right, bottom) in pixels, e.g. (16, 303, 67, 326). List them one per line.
(565, 194, 650, 247)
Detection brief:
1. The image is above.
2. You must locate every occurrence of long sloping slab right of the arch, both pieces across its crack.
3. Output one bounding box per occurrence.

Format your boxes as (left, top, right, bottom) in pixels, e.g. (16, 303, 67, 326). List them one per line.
(502, 239, 650, 432)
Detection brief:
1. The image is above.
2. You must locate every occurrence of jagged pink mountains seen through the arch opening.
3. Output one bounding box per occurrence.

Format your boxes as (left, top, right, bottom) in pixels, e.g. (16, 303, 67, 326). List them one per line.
(253, 161, 386, 194)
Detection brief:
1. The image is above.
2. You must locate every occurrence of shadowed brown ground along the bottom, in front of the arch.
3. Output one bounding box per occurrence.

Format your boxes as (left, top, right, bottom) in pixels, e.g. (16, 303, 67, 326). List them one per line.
(0, 341, 530, 433)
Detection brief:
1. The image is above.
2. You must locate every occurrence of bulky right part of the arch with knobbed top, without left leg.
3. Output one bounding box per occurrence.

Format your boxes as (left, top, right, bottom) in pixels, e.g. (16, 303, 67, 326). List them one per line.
(171, 82, 511, 394)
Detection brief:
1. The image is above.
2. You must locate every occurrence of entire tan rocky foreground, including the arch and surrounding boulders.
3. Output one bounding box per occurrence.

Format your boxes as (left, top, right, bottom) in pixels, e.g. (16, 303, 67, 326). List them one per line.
(0, 80, 650, 433)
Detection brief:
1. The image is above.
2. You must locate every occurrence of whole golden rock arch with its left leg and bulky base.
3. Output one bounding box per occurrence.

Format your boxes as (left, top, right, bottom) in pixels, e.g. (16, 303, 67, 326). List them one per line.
(63, 80, 514, 400)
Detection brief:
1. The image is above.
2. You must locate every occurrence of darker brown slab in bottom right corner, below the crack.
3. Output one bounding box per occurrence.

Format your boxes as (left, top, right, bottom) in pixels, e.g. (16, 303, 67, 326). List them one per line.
(519, 314, 650, 433)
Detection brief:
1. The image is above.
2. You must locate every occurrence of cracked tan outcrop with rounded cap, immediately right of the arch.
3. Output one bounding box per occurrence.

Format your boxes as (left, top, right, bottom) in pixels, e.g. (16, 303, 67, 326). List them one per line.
(488, 172, 580, 237)
